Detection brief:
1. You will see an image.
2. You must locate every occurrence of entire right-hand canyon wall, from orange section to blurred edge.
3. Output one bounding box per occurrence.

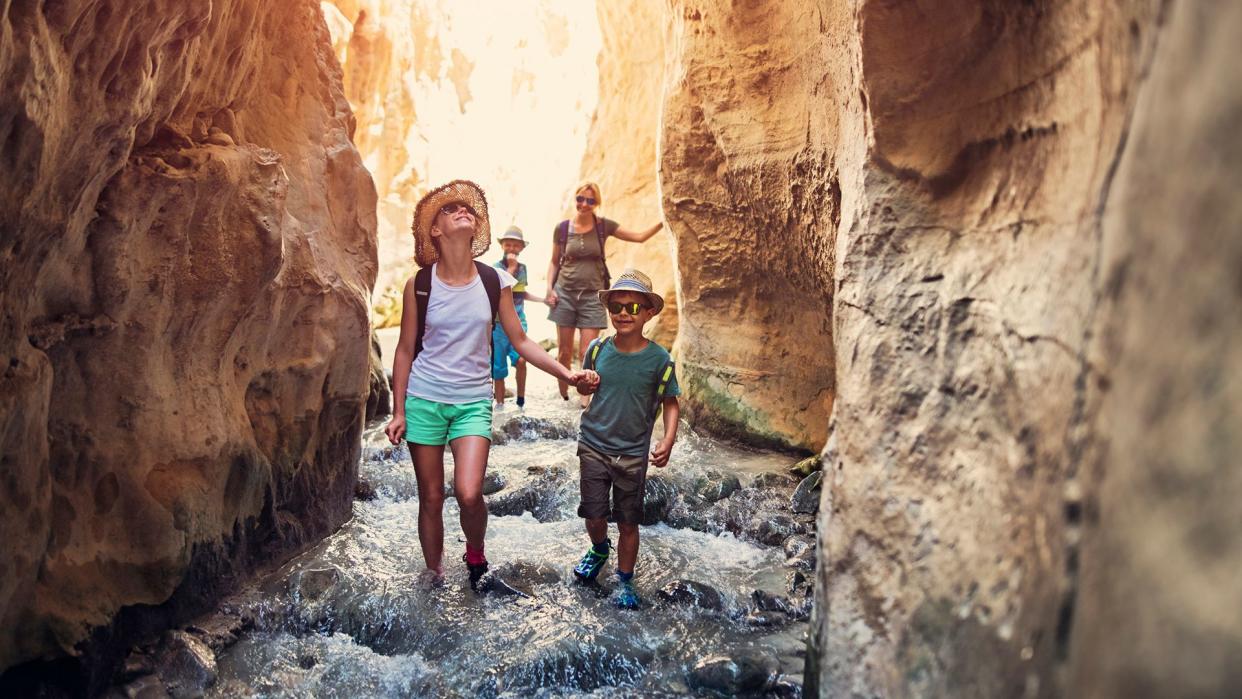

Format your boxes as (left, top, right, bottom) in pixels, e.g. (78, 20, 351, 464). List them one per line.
(658, 0, 1242, 697)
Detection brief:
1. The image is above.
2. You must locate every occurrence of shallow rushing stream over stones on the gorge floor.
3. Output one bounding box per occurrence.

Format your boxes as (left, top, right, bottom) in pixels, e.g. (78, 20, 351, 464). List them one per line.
(196, 372, 818, 697)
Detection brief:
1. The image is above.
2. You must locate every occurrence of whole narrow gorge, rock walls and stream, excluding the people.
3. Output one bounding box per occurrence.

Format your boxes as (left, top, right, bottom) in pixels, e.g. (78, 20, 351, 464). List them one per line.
(0, 0, 1242, 697)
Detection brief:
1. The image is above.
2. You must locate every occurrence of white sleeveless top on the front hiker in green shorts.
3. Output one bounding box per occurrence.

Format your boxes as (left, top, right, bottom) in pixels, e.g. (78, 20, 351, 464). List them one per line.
(406, 263, 518, 404)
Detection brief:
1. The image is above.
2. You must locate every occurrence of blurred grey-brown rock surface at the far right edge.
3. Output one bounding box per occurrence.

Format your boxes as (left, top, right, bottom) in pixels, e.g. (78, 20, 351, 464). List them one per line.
(1069, 2, 1242, 697)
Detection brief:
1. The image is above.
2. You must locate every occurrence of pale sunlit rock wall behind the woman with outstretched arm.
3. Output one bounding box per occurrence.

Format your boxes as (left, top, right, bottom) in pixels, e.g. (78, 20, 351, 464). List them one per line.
(581, 0, 678, 348)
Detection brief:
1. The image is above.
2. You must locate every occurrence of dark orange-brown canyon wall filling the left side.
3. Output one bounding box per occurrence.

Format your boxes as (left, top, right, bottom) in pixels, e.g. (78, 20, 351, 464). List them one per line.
(0, 0, 375, 668)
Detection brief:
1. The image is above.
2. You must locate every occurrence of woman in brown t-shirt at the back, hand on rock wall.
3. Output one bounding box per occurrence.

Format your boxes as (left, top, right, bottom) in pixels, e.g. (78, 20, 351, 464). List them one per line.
(548, 183, 664, 406)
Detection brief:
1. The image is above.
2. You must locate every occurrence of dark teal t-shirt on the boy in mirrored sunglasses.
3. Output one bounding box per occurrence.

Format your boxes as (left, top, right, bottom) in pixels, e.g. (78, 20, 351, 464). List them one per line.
(579, 341, 682, 456)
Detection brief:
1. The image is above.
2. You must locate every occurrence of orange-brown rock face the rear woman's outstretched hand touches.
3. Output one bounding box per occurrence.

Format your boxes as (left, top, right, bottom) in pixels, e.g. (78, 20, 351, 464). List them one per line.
(660, 1, 847, 451)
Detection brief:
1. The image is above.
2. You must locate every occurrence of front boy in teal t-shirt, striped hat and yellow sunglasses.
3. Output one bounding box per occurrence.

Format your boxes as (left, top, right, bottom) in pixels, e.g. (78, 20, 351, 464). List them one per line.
(574, 269, 681, 608)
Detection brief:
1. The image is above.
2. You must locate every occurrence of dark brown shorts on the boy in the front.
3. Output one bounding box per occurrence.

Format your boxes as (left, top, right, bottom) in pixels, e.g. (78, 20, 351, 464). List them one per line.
(578, 442, 647, 524)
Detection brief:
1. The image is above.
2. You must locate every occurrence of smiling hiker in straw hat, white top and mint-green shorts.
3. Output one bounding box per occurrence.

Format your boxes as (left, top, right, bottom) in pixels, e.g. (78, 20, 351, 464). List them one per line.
(384, 180, 599, 590)
